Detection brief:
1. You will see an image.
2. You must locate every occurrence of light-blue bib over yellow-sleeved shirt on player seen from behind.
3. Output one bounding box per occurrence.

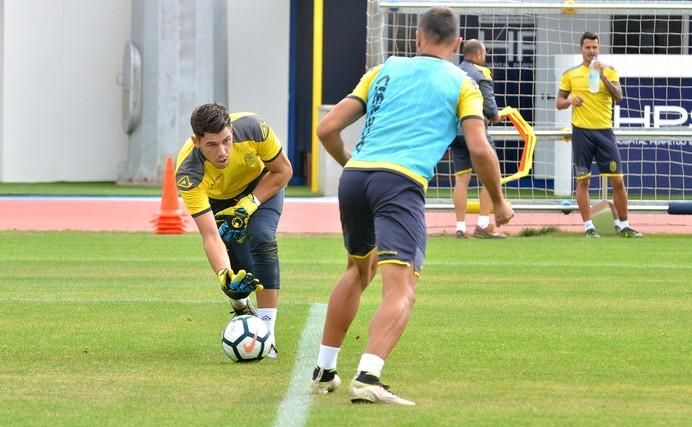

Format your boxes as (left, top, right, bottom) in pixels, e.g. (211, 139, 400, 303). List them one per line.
(346, 56, 483, 188)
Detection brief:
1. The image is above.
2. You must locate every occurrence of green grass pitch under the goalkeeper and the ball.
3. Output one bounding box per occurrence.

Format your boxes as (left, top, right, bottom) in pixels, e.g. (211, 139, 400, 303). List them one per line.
(0, 232, 692, 427)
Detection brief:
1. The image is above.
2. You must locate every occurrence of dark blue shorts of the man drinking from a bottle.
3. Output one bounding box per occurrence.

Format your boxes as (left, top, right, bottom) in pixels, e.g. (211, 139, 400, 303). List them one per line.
(572, 126, 622, 179)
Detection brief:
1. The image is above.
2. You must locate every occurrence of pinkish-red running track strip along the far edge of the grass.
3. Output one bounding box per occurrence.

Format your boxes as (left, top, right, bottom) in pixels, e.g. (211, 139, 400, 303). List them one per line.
(0, 197, 692, 234)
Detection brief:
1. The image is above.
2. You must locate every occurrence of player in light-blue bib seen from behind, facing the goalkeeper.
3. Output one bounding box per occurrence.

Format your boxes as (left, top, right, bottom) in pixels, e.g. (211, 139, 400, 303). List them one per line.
(310, 6, 514, 406)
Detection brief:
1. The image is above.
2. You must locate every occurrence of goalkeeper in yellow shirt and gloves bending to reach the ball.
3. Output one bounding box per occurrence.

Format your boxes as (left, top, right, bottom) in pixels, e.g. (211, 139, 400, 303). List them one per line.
(176, 104, 293, 357)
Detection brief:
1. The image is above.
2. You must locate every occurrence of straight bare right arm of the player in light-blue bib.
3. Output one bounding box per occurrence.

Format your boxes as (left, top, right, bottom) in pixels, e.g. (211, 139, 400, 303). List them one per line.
(462, 118, 514, 226)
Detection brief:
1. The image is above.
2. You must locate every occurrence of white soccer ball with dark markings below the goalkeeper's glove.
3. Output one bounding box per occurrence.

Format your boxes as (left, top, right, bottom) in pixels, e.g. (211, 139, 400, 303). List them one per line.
(221, 315, 274, 362)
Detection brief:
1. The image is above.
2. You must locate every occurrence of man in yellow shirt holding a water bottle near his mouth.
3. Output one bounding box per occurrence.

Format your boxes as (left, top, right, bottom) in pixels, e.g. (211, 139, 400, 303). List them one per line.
(555, 31, 643, 238)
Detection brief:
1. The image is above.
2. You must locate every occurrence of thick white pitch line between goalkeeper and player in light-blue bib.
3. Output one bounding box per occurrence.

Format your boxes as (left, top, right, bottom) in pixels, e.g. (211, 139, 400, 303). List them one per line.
(274, 304, 327, 427)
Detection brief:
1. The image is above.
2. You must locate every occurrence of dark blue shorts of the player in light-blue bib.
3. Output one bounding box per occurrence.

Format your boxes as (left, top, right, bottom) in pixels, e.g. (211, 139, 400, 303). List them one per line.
(339, 169, 427, 273)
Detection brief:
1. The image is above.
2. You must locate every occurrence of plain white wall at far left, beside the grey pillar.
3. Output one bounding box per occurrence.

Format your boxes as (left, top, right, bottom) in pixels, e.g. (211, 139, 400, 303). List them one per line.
(0, 0, 131, 182)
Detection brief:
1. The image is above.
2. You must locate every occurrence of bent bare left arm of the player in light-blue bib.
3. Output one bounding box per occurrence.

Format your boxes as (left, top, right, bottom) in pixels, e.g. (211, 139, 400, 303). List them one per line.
(317, 98, 365, 166)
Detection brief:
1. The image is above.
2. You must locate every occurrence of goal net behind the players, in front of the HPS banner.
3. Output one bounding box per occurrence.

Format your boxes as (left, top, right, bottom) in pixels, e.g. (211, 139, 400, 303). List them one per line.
(367, 0, 692, 209)
